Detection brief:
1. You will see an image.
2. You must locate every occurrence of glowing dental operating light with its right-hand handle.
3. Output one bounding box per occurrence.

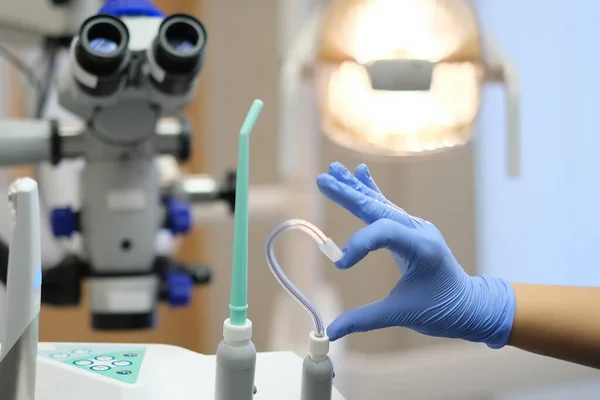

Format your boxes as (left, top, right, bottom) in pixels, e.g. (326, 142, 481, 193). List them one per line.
(311, 0, 519, 175)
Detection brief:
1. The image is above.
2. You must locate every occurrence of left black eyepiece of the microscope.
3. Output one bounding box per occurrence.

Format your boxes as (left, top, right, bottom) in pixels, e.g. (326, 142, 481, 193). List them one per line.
(74, 14, 130, 95)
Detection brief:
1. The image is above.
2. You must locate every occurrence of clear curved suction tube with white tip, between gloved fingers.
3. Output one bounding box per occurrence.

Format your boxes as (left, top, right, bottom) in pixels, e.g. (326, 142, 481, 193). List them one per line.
(265, 219, 342, 338)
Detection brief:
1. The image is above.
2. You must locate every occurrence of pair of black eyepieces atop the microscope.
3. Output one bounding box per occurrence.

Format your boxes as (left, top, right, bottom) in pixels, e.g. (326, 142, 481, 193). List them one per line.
(72, 14, 206, 96)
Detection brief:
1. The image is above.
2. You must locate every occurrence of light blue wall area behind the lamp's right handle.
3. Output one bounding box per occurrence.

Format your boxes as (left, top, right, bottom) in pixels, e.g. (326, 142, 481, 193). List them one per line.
(476, 0, 600, 400)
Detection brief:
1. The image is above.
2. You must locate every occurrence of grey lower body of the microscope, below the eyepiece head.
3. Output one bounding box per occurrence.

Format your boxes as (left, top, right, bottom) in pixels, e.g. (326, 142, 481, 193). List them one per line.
(79, 138, 165, 329)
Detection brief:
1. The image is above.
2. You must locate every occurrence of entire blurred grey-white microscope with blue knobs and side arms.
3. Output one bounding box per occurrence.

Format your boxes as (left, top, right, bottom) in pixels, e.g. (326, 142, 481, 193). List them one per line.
(0, 0, 235, 330)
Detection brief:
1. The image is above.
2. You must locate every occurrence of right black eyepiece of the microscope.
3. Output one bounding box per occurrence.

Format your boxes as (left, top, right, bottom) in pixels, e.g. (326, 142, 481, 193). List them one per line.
(149, 14, 206, 94)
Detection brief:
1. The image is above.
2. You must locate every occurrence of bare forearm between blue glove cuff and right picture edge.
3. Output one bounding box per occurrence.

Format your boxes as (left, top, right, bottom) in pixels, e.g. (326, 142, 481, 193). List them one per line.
(509, 283, 600, 369)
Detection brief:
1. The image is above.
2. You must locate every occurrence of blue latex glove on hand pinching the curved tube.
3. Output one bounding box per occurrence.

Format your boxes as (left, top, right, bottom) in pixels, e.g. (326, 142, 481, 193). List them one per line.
(317, 163, 515, 348)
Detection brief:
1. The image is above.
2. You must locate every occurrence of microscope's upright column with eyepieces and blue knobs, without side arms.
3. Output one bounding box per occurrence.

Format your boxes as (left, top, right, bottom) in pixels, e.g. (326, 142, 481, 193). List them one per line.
(55, 14, 206, 329)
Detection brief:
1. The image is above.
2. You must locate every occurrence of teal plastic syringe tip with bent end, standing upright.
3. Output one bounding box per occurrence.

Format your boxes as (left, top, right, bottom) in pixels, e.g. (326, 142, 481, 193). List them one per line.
(229, 99, 263, 325)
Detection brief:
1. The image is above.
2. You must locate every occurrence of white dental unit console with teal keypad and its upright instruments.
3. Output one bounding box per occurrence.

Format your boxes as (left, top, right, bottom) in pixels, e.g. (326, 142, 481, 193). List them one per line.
(0, 101, 344, 400)
